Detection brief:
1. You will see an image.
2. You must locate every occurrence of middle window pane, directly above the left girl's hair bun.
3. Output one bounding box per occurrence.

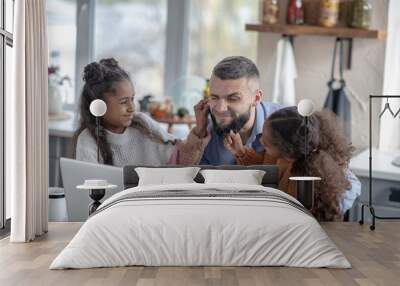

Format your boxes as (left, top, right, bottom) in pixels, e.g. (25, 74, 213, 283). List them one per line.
(94, 0, 167, 100)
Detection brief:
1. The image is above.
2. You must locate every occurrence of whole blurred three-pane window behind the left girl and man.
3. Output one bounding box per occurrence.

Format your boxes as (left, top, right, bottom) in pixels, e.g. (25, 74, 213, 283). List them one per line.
(47, 0, 259, 106)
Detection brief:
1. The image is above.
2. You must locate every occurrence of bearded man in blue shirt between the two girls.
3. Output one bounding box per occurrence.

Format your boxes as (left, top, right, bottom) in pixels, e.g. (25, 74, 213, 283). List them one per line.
(186, 56, 361, 213)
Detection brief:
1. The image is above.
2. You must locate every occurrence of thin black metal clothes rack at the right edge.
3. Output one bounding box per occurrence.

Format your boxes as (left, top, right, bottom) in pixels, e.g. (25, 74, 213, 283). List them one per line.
(359, 95, 400, 230)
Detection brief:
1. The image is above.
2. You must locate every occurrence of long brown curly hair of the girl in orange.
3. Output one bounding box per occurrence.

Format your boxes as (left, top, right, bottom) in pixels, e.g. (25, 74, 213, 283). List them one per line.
(267, 107, 354, 221)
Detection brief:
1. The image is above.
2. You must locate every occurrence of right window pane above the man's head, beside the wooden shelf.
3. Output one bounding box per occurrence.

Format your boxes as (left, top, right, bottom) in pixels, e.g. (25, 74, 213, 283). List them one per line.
(188, 0, 259, 78)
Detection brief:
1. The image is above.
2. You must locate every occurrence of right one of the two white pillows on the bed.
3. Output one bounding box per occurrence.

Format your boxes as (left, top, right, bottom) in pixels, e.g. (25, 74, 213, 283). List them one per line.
(200, 170, 265, 185)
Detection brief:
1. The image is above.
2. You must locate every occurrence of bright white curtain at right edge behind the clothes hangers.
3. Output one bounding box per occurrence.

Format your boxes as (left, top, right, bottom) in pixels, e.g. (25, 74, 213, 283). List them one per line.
(379, 0, 400, 150)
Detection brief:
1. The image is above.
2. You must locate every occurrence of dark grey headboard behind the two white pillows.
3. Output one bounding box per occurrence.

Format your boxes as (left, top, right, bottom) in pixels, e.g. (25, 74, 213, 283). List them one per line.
(124, 165, 279, 189)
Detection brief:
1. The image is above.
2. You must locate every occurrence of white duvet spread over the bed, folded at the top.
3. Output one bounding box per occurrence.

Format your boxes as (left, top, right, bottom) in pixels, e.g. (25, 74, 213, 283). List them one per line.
(50, 183, 351, 269)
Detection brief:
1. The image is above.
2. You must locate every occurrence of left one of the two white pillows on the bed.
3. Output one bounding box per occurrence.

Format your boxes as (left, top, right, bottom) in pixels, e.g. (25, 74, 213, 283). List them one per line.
(135, 167, 200, 186)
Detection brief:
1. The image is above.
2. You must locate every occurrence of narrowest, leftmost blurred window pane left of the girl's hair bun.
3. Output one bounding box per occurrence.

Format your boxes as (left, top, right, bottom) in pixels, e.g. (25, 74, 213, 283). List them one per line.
(46, 0, 76, 106)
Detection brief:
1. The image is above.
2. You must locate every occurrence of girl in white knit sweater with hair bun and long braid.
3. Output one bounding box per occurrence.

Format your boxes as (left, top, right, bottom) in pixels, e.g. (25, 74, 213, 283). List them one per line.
(73, 58, 208, 166)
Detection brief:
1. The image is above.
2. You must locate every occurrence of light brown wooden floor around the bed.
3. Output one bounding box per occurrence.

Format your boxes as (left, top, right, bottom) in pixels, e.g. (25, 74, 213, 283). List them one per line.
(0, 222, 400, 286)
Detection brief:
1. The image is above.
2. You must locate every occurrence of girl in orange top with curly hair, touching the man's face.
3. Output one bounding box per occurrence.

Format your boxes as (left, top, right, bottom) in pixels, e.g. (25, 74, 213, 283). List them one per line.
(224, 107, 353, 221)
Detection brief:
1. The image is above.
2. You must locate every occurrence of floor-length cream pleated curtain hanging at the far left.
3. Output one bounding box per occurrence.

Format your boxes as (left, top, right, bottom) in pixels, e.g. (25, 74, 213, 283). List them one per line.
(6, 0, 48, 242)
